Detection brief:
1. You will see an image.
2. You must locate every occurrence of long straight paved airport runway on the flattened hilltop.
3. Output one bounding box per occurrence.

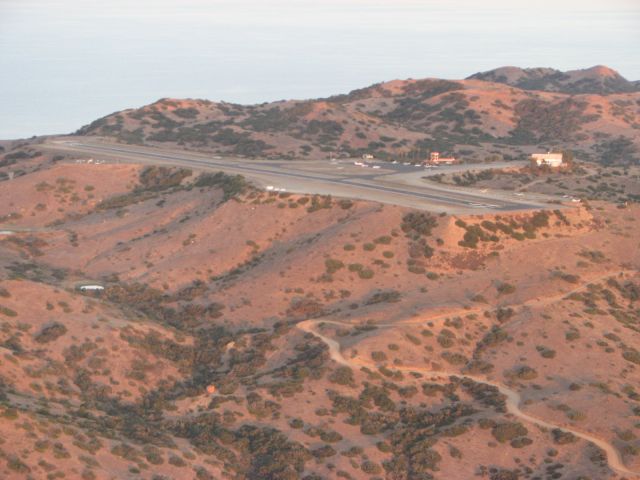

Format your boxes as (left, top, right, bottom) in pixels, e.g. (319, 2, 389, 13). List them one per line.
(43, 139, 548, 213)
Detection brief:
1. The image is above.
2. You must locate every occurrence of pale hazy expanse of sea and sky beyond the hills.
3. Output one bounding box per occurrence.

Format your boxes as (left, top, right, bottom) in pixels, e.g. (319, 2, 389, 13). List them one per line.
(0, 0, 640, 139)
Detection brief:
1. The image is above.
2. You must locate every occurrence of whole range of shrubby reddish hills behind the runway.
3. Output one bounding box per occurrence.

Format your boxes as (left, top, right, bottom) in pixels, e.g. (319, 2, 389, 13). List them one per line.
(77, 67, 640, 164)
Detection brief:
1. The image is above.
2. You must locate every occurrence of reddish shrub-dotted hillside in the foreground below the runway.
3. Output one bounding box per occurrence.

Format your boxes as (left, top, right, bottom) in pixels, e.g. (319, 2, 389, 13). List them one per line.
(0, 159, 640, 480)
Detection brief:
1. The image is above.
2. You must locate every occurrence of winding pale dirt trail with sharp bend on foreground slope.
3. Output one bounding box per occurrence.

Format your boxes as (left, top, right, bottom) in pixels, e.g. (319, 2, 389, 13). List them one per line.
(297, 272, 640, 479)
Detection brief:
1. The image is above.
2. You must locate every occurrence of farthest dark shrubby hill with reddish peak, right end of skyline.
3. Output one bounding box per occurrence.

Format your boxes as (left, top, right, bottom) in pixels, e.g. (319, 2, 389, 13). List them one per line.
(468, 65, 640, 95)
